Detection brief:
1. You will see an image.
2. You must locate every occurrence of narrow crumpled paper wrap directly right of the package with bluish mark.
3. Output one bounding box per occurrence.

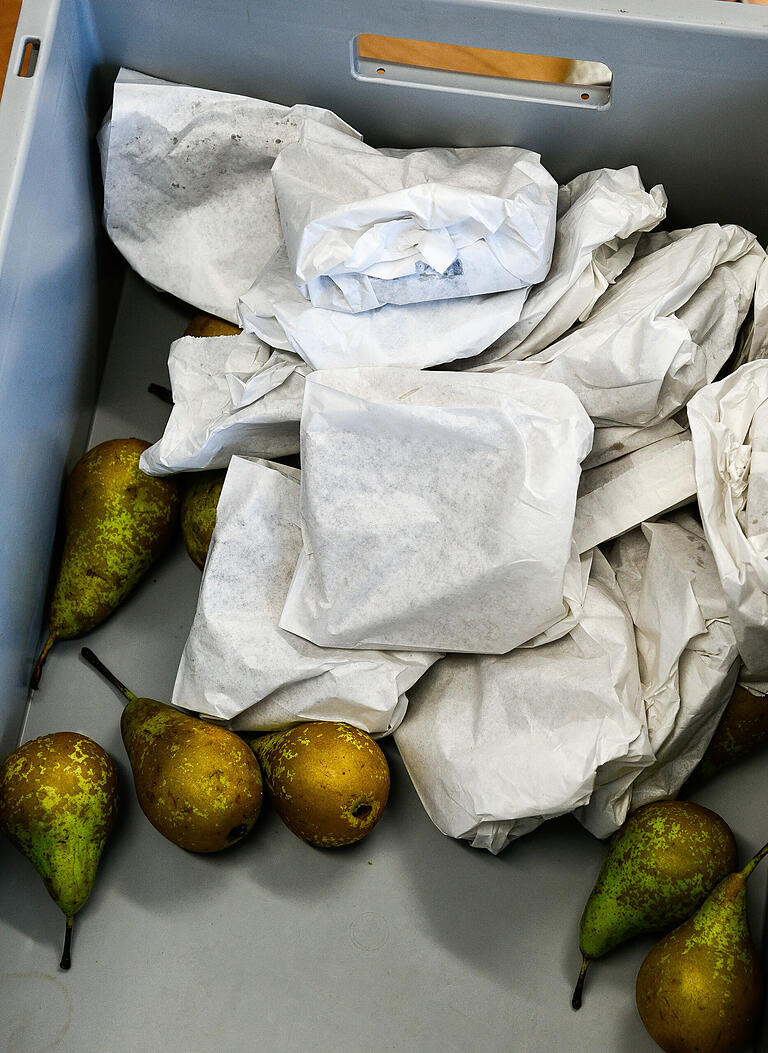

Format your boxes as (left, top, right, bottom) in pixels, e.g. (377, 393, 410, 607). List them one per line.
(461, 165, 667, 367)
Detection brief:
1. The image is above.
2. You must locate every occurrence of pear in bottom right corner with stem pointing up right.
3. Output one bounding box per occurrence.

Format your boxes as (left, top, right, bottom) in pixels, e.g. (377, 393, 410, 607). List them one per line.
(636, 845, 768, 1053)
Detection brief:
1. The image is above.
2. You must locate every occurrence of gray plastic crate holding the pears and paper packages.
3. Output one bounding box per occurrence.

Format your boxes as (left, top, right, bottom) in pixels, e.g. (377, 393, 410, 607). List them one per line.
(0, 0, 768, 1053)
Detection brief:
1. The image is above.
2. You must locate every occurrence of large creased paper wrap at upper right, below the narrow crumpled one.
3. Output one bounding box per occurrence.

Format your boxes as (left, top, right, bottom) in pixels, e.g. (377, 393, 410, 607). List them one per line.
(474, 223, 765, 426)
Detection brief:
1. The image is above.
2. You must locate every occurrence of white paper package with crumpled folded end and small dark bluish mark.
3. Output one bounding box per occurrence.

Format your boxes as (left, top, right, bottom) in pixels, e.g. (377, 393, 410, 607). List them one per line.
(272, 121, 557, 313)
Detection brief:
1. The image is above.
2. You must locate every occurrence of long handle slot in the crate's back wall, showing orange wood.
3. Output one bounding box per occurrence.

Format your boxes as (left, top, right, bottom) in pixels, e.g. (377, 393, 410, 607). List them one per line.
(352, 33, 613, 110)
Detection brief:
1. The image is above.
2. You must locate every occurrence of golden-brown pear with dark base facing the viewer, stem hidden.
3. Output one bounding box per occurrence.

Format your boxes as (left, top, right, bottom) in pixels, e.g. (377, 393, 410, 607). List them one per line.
(251, 720, 390, 848)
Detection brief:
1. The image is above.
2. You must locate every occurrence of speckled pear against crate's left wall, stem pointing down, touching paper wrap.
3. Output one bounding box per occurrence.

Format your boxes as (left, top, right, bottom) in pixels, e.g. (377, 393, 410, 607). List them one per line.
(31, 439, 179, 688)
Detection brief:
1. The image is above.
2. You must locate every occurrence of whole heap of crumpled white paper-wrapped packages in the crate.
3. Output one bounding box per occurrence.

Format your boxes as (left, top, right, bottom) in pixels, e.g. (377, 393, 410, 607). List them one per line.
(100, 71, 768, 852)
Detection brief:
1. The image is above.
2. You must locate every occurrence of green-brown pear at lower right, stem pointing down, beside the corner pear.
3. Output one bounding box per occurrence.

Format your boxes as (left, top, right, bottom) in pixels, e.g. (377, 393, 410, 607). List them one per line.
(571, 800, 736, 1009)
